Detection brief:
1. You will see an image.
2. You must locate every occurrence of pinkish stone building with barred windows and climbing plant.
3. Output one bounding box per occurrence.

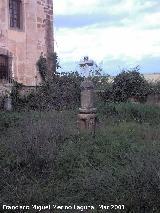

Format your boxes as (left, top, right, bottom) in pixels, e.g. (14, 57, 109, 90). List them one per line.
(0, 0, 54, 86)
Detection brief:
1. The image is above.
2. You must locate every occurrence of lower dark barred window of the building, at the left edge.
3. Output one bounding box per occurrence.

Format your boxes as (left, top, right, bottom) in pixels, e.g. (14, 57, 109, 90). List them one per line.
(0, 55, 10, 80)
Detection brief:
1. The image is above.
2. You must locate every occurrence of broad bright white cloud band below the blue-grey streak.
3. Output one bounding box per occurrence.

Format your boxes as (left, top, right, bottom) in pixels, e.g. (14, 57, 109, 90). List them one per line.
(56, 24, 160, 61)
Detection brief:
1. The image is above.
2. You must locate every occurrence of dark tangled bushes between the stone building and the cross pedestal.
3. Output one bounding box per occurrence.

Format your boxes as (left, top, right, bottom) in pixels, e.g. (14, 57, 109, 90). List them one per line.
(12, 72, 83, 110)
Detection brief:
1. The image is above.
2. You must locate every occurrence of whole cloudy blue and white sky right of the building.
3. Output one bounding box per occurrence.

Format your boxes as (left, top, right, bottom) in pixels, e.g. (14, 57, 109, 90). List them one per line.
(53, 0, 160, 76)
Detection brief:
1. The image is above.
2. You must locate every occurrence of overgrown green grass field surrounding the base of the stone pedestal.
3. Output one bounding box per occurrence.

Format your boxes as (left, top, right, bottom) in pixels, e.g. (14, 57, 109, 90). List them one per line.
(0, 104, 160, 213)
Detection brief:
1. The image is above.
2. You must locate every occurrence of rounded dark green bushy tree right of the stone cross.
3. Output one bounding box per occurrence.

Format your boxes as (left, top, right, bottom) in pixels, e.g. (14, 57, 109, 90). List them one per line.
(112, 66, 149, 102)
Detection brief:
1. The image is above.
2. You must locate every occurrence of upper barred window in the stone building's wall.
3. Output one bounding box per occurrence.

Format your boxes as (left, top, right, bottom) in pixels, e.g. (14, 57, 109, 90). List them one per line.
(9, 0, 21, 29)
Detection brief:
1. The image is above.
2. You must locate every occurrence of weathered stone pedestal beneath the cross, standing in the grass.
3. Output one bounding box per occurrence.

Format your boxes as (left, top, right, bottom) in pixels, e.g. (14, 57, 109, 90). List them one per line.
(78, 79, 96, 135)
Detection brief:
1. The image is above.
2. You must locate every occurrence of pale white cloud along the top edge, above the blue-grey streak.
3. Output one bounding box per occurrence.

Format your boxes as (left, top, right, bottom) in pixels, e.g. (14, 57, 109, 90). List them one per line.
(54, 0, 160, 15)
